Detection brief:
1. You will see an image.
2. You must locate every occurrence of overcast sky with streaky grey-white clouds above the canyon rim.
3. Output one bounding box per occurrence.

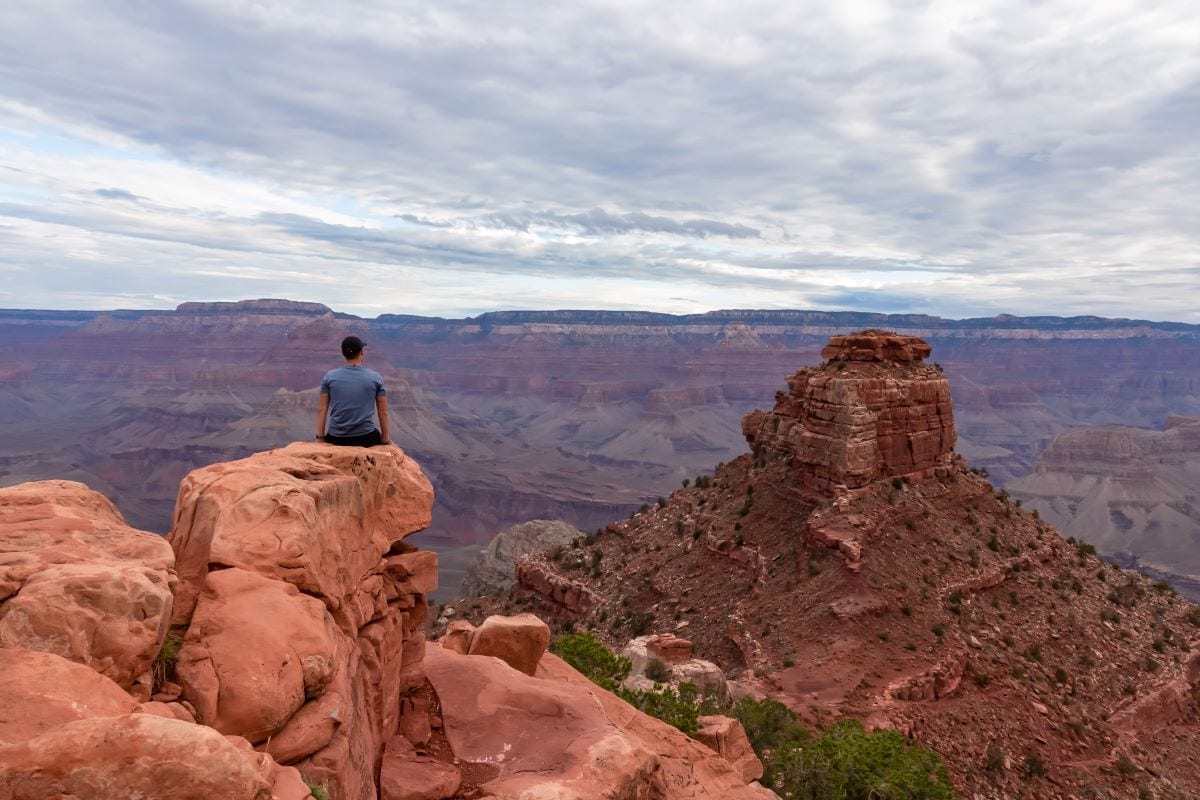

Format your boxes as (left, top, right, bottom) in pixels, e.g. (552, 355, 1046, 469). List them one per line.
(0, 0, 1200, 323)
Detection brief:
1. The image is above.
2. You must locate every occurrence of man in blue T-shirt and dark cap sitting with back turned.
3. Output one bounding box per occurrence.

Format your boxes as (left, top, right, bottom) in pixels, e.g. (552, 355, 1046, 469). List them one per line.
(317, 336, 390, 447)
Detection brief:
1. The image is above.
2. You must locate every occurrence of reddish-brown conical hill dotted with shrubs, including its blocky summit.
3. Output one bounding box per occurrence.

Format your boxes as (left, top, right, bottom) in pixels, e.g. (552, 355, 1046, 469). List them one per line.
(463, 332, 1200, 800)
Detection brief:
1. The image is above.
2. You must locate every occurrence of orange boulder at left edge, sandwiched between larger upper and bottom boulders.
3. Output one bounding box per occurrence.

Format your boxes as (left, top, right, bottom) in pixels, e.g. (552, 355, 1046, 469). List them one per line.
(0, 648, 137, 745)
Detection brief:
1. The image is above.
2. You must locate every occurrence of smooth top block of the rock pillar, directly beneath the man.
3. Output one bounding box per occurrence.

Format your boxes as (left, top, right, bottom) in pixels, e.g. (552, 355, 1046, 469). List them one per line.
(168, 443, 433, 624)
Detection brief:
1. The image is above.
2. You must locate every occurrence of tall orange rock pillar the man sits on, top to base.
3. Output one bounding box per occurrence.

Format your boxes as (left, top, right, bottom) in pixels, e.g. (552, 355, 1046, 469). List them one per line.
(168, 444, 437, 798)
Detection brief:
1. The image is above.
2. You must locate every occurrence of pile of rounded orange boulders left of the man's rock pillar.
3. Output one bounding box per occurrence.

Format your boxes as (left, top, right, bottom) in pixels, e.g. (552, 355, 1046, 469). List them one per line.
(0, 489, 316, 800)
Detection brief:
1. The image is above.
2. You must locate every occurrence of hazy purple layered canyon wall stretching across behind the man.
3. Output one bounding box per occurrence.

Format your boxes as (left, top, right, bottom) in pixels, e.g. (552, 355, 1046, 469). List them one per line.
(0, 301, 1200, 594)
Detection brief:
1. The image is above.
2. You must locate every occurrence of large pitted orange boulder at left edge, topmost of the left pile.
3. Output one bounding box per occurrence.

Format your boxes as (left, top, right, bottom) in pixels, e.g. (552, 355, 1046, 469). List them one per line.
(0, 481, 175, 688)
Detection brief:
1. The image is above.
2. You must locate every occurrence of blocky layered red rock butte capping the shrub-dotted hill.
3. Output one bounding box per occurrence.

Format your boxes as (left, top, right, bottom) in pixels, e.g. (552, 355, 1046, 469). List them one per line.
(742, 331, 956, 492)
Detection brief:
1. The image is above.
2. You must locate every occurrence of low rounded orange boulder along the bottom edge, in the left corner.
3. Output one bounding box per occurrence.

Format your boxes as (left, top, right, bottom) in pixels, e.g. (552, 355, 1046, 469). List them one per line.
(0, 714, 271, 800)
